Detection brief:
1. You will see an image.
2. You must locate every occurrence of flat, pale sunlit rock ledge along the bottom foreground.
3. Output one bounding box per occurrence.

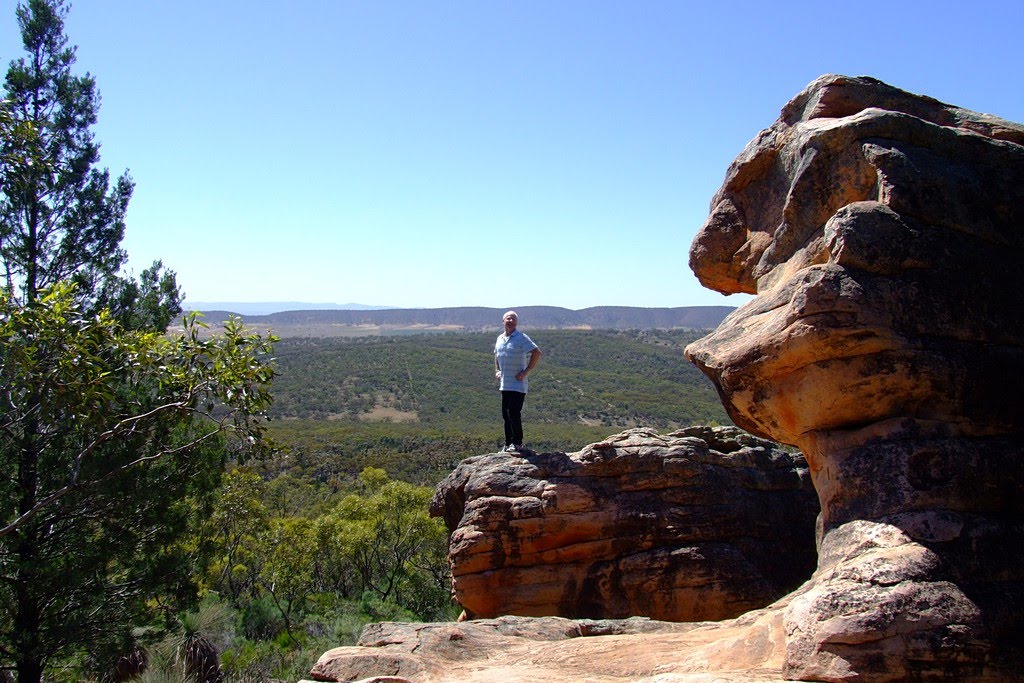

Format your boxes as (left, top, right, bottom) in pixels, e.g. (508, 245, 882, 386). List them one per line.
(310, 611, 784, 683)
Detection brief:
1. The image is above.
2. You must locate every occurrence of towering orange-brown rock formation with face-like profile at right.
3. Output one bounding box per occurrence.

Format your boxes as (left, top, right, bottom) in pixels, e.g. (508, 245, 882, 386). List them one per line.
(686, 76, 1024, 681)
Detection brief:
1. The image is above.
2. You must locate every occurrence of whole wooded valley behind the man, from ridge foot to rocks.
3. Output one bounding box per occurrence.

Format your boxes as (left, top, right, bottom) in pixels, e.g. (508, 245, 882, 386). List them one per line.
(262, 330, 729, 483)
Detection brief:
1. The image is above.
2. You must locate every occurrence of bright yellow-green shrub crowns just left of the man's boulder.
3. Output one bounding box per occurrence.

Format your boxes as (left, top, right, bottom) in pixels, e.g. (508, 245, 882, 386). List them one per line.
(208, 468, 449, 622)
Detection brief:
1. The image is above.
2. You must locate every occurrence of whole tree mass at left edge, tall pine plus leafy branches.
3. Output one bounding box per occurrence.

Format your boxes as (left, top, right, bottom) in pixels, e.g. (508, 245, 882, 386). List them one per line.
(0, 0, 273, 683)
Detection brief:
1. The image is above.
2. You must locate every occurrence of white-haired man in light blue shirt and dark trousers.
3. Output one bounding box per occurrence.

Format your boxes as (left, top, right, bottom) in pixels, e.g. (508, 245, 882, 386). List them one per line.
(495, 310, 541, 452)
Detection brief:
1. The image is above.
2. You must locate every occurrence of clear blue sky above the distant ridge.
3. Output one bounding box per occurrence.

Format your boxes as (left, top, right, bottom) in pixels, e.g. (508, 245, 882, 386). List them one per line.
(0, 0, 1024, 308)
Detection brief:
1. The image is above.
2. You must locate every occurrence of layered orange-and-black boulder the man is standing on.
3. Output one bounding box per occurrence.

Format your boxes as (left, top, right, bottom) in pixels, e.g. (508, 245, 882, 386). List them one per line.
(431, 427, 818, 622)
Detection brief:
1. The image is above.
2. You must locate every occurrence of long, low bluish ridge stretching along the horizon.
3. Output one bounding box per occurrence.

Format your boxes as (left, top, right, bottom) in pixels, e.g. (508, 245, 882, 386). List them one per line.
(182, 306, 734, 331)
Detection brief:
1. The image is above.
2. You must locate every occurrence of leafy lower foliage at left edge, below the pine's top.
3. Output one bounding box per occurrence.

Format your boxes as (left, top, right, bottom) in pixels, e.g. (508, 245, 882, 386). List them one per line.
(0, 286, 272, 681)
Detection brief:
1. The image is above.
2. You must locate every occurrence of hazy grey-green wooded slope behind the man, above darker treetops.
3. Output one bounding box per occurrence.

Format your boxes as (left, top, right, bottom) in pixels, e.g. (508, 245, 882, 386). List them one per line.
(271, 330, 725, 427)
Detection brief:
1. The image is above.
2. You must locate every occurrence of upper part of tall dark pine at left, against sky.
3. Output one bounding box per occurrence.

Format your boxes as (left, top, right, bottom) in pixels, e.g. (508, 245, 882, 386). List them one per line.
(0, 0, 133, 303)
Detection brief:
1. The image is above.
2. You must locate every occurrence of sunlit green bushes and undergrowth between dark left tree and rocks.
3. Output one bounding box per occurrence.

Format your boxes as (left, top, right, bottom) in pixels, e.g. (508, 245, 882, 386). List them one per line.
(185, 468, 455, 681)
